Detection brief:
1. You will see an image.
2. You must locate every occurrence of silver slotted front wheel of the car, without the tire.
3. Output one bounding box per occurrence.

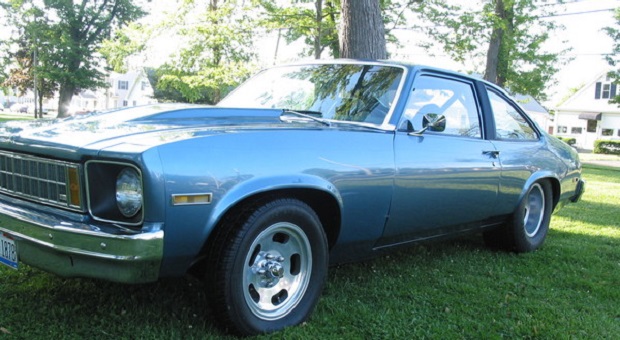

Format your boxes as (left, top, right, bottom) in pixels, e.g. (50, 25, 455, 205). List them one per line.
(243, 222, 312, 320)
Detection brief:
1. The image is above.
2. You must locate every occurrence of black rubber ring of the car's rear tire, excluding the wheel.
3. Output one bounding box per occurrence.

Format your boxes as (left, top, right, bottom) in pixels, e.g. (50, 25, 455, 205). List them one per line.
(512, 181, 552, 252)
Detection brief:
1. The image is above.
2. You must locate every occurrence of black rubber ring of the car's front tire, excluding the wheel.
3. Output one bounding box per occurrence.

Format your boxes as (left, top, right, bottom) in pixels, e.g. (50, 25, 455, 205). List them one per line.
(221, 199, 328, 335)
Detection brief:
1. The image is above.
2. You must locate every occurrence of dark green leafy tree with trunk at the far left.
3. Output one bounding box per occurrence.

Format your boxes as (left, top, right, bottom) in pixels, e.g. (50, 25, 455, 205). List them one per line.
(6, 0, 145, 117)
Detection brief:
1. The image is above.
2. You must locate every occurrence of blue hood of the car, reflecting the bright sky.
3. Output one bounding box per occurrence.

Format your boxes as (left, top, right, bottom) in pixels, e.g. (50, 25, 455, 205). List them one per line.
(0, 104, 282, 156)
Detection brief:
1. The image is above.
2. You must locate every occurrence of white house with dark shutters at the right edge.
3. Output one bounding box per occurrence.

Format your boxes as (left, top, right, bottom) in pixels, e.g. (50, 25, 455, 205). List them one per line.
(553, 72, 620, 150)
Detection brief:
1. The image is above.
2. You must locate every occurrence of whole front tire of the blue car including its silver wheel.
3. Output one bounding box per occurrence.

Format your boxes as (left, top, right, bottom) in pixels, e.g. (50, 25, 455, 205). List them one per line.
(207, 199, 328, 335)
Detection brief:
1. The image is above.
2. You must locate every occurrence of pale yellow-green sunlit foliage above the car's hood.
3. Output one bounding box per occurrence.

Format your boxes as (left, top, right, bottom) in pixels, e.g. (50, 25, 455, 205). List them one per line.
(102, 0, 256, 104)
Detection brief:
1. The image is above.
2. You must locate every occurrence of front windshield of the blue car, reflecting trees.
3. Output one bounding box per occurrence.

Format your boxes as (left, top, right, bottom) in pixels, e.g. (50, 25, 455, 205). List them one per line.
(218, 64, 404, 124)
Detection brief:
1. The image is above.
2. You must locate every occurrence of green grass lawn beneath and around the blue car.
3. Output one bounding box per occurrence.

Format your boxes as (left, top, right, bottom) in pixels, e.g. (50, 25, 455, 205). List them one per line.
(0, 167, 620, 339)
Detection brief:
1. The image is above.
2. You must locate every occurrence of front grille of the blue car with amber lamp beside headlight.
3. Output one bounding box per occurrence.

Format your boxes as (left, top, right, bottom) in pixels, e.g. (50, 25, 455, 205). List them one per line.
(0, 151, 83, 210)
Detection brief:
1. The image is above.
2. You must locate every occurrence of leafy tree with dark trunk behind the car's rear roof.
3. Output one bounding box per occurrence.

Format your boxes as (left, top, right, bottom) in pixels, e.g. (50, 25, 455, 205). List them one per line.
(419, 0, 565, 99)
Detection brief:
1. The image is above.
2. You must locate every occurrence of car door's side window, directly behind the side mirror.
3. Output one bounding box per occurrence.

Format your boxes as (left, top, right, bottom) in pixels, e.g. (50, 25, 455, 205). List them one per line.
(399, 75, 482, 138)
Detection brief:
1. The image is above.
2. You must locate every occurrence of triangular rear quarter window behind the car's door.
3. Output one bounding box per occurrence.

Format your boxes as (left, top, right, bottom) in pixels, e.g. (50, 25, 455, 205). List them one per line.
(487, 90, 538, 140)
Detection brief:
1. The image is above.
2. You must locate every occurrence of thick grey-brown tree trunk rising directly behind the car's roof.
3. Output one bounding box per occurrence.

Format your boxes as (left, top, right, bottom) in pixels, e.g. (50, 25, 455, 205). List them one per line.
(340, 0, 387, 59)
